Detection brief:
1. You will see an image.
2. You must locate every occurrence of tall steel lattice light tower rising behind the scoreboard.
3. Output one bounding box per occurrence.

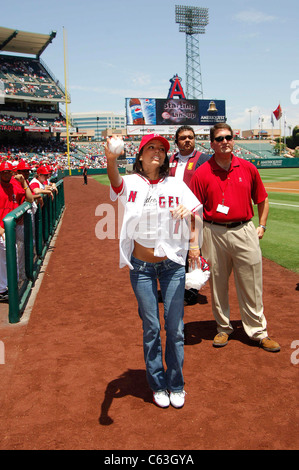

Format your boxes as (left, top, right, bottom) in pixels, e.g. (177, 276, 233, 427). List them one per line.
(175, 5, 209, 99)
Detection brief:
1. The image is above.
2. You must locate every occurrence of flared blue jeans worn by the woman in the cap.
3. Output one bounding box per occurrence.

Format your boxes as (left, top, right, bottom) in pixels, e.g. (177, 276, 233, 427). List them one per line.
(130, 256, 185, 392)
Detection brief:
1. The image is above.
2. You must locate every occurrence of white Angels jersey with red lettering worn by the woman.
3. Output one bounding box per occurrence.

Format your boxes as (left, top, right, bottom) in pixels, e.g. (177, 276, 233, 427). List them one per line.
(110, 174, 202, 269)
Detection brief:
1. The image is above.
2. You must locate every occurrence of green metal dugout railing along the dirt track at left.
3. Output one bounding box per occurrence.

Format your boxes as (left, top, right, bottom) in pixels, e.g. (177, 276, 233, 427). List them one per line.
(3, 180, 65, 323)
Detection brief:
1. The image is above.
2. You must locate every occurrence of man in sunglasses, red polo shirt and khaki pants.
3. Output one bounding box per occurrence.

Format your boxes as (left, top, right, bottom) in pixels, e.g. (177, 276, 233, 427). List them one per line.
(190, 123, 280, 352)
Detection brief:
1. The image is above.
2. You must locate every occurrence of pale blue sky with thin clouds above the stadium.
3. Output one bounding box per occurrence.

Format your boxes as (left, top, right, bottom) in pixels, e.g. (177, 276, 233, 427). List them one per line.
(0, 0, 299, 135)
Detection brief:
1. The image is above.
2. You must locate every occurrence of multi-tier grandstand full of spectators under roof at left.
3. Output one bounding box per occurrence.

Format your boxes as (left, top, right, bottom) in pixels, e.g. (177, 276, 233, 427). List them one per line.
(0, 27, 76, 165)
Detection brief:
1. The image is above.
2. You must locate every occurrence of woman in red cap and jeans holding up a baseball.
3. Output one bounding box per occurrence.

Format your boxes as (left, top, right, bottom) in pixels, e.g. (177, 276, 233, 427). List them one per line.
(105, 134, 202, 408)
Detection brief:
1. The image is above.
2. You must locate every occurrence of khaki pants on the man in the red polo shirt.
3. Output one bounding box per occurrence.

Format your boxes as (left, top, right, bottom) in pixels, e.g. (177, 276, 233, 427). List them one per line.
(202, 222, 268, 340)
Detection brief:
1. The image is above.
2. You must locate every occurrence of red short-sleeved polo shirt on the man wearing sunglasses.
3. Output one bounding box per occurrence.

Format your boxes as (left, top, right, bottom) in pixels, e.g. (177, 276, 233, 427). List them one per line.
(190, 155, 268, 223)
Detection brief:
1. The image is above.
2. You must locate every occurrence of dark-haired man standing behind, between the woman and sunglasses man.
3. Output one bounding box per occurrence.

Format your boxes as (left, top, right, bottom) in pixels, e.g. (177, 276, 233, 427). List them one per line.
(169, 125, 210, 305)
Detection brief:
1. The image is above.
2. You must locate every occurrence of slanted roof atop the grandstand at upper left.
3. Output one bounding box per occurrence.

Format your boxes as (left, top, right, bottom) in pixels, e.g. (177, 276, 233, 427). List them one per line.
(0, 27, 56, 58)
